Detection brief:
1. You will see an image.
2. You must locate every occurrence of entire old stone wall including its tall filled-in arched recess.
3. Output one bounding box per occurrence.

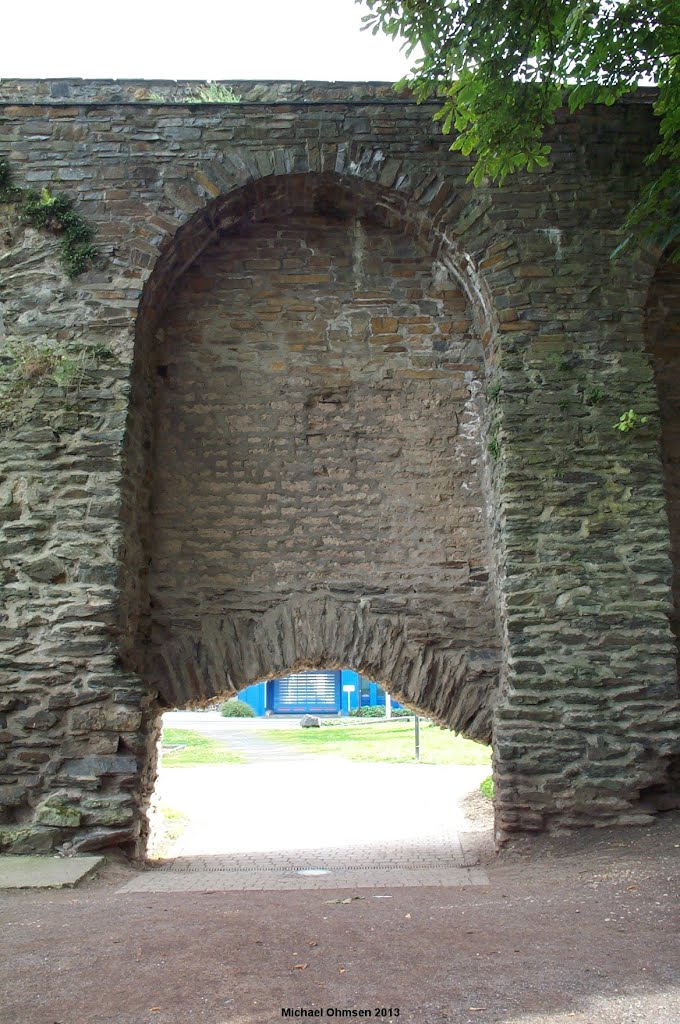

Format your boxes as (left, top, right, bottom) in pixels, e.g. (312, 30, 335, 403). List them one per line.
(0, 81, 680, 853)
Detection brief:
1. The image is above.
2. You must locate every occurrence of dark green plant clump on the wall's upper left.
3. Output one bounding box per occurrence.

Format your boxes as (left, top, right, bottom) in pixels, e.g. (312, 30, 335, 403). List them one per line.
(0, 158, 97, 278)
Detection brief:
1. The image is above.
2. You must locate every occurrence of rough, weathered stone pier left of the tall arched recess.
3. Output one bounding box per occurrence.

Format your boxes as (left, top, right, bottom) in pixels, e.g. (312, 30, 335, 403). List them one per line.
(0, 207, 156, 853)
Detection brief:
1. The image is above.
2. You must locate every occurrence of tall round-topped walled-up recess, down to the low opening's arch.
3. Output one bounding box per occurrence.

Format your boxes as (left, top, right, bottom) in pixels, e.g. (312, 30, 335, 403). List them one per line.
(118, 169, 500, 847)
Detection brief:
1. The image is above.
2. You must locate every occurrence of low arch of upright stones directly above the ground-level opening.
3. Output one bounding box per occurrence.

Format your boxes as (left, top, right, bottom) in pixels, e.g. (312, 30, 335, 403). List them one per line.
(150, 594, 496, 742)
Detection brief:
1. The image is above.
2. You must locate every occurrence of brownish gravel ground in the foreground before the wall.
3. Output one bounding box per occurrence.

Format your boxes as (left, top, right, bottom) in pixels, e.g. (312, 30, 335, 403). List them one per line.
(0, 811, 680, 1024)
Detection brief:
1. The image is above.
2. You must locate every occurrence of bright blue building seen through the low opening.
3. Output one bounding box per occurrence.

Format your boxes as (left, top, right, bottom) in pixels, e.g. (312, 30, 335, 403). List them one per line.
(239, 669, 400, 715)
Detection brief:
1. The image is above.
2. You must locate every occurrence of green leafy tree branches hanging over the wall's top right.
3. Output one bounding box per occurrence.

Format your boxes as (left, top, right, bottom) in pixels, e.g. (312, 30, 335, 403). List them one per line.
(356, 0, 680, 257)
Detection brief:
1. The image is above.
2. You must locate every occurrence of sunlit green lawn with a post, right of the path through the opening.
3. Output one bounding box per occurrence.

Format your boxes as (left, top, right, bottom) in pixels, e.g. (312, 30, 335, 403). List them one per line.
(257, 720, 492, 765)
